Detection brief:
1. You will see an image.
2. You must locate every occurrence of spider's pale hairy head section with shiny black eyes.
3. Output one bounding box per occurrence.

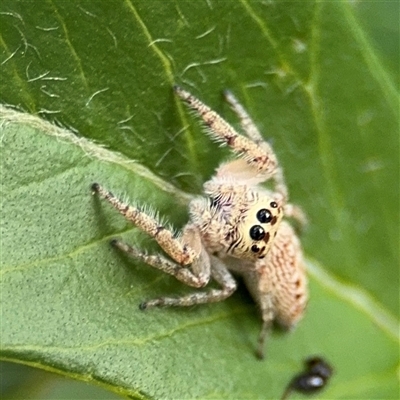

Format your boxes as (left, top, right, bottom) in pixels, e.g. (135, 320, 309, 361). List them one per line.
(191, 188, 283, 260)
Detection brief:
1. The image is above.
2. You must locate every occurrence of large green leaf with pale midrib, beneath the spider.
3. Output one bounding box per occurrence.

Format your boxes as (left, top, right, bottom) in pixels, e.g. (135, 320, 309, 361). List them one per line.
(0, 0, 399, 399)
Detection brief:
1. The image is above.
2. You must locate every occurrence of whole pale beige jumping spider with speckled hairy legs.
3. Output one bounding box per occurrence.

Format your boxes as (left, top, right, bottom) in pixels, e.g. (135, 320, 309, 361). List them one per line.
(92, 86, 307, 358)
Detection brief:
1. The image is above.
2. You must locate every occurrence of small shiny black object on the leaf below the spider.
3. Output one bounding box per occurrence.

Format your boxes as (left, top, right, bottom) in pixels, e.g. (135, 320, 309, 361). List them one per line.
(281, 357, 333, 400)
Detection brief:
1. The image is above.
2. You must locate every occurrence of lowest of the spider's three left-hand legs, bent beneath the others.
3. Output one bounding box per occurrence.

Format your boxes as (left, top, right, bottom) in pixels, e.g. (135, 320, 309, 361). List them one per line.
(140, 256, 237, 309)
